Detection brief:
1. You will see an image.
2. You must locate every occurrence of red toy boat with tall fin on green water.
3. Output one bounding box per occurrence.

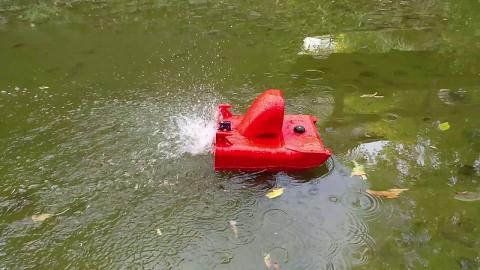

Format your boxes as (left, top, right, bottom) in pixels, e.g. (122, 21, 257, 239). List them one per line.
(215, 89, 332, 171)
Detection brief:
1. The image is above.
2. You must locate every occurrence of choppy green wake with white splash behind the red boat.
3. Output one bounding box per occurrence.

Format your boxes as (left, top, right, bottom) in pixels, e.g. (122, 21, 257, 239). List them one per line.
(2, 85, 225, 268)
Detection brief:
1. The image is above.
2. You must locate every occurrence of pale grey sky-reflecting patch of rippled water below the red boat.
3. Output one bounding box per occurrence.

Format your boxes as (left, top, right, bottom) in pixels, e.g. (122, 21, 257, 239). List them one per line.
(174, 162, 378, 269)
